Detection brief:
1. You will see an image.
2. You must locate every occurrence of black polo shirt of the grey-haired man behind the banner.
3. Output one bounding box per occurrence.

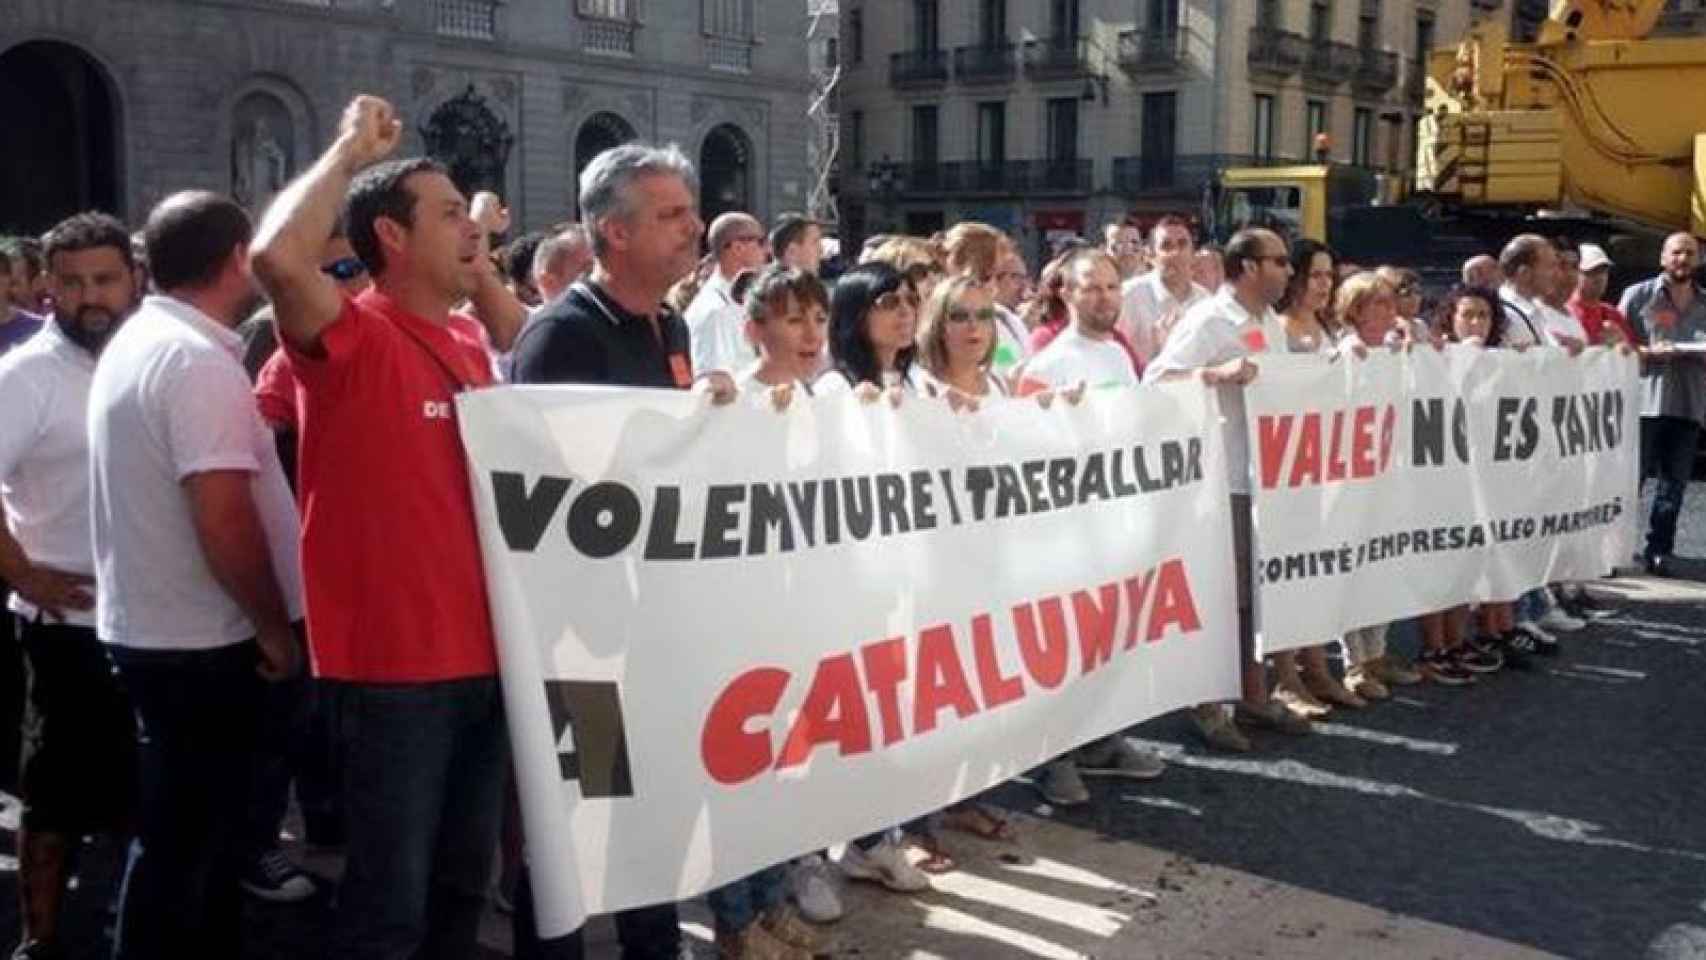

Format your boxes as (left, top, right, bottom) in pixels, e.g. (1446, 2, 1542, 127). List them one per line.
(510, 281, 693, 389)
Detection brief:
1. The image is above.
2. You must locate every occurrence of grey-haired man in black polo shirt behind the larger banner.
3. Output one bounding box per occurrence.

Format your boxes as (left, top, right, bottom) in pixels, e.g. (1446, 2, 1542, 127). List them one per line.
(510, 143, 705, 958)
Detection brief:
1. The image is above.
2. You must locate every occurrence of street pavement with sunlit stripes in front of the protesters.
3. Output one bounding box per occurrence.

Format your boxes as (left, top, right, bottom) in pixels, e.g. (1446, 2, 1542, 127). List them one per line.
(0, 488, 1706, 960)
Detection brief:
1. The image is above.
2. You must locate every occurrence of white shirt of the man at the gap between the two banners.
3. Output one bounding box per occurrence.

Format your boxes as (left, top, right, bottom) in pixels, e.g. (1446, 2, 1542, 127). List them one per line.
(1148, 286, 1286, 493)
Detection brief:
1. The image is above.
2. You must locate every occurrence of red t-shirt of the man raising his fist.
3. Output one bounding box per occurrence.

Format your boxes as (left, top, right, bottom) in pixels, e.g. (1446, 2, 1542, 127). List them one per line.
(290, 290, 496, 684)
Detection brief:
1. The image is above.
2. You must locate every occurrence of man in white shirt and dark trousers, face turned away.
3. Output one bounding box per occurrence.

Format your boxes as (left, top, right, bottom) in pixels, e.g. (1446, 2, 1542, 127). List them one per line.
(89, 193, 302, 960)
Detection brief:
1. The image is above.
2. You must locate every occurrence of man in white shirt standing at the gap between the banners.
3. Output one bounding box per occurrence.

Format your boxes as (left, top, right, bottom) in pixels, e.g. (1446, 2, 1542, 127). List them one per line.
(1148, 228, 1310, 752)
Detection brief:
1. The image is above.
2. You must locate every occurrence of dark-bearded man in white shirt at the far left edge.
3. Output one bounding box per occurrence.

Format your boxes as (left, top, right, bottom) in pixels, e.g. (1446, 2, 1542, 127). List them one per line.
(0, 213, 136, 958)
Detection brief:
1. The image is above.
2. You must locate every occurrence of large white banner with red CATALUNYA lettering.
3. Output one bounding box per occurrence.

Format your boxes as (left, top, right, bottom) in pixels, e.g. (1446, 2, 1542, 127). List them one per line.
(457, 384, 1237, 936)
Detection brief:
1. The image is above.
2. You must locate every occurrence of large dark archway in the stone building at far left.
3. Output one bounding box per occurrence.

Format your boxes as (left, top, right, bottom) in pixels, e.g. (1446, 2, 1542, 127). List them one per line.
(0, 41, 125, 234)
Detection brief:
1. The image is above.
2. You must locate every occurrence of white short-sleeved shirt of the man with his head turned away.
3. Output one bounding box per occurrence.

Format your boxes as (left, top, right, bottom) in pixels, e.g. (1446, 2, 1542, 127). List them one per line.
(89, 297, 303, 650)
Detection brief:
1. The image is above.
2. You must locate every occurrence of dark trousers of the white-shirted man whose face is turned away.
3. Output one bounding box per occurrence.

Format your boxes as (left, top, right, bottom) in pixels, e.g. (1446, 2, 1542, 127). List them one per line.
(109, 641, 264, 960)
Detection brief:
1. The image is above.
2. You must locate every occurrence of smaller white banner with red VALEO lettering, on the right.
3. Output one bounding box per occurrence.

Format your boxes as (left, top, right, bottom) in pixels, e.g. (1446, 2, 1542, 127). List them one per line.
(1245, 346, 1641, 653)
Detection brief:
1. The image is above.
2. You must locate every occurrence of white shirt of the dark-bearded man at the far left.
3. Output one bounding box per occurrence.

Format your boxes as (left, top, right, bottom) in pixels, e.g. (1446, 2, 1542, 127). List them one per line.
(0, 317, 96, 627)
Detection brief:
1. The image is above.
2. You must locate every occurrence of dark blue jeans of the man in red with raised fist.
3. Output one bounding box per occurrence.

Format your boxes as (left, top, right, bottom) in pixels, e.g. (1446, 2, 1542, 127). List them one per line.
(326, 677, 510, 960)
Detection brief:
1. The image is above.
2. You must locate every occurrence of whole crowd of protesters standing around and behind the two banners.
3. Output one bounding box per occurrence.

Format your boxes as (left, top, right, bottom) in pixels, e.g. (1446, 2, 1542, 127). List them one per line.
(0, 97, 1706, 960)
